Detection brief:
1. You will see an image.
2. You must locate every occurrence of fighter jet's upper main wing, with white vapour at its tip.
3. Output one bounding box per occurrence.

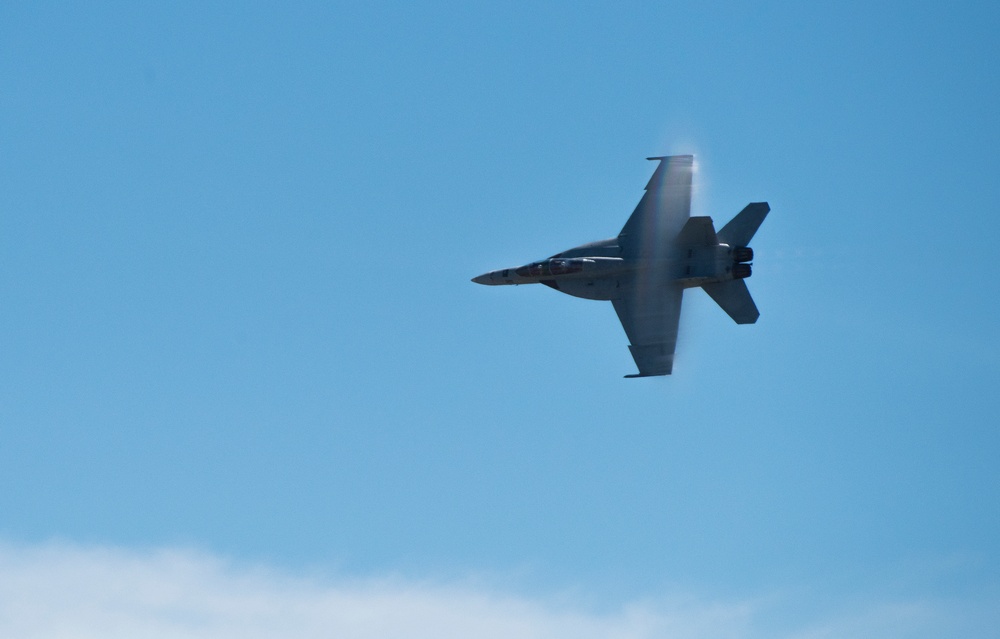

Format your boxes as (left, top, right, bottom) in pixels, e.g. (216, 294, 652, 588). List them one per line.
(618, 155, 694, 260)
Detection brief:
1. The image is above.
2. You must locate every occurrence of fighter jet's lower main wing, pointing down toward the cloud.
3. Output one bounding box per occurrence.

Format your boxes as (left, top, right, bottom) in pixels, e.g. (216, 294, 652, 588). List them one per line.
(611, 280, 684, 377)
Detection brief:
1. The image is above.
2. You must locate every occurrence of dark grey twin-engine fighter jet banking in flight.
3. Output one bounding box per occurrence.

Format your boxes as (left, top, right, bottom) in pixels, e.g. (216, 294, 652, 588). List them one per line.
(472, 155, 771, 377)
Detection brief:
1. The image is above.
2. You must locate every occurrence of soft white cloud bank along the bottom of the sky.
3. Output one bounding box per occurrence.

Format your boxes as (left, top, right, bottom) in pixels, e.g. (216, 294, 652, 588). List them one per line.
(0, 545, 998, 639)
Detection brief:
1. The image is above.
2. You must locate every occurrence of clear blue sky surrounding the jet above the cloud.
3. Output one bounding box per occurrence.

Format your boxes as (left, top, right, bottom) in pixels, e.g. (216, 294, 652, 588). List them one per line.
(0, 2, 1000, 636)
